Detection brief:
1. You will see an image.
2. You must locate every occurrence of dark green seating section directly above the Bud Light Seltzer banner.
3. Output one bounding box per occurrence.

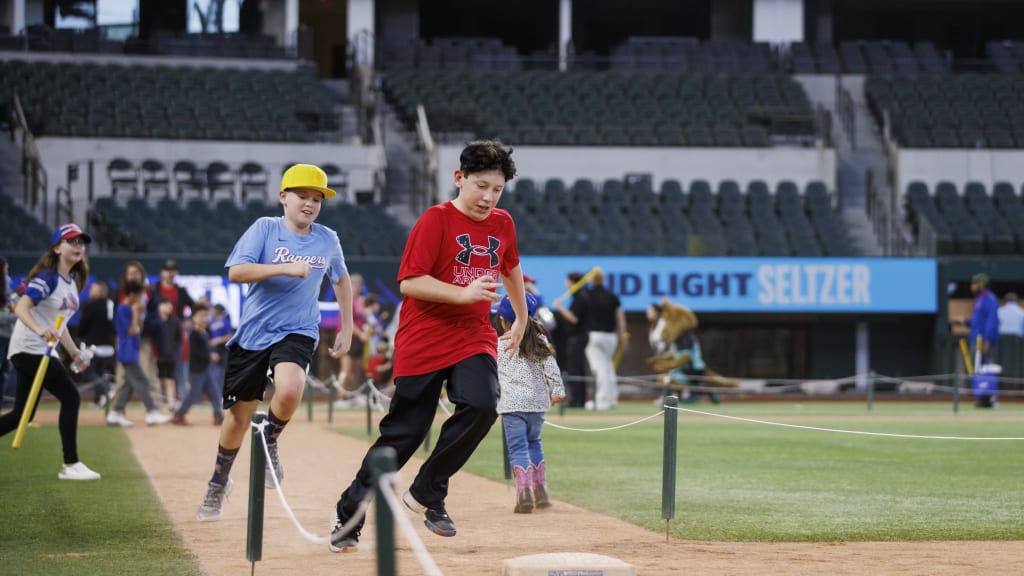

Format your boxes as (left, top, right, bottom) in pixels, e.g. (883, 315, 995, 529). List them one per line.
(501, 178, 854, 256)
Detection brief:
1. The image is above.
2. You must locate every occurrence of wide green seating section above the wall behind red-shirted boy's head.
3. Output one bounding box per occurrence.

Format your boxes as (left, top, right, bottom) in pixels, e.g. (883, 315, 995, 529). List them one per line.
(384, 71, 816, 147)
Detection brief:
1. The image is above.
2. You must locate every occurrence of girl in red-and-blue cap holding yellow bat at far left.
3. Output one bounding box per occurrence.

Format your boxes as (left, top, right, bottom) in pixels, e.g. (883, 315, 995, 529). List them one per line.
(0, 223, 99, 480)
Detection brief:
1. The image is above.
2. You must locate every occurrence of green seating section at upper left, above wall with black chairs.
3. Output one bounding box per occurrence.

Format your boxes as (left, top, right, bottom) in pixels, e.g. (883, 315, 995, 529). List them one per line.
(0, 59, 339, 141)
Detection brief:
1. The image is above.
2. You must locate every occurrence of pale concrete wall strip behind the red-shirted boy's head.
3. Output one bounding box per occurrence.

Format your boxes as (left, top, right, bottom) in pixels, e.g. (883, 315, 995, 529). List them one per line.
(437, 146, 836, 198)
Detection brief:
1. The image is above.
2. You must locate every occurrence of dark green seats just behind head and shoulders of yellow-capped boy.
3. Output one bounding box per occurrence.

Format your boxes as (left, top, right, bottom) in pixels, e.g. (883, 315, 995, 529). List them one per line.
(87, 197, 409, 257)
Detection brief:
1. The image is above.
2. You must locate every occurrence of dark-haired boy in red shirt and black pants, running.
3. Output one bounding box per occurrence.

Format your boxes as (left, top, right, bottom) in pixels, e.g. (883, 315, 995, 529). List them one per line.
(329, 140, 528, 552)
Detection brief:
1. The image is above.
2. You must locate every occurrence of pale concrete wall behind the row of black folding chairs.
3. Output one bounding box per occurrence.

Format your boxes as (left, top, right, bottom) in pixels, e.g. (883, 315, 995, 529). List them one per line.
(37, 137, 386, 221)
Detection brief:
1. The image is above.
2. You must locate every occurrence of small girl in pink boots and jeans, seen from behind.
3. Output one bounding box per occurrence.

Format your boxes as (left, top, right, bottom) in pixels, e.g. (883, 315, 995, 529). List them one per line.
(498, 292, 565, 513)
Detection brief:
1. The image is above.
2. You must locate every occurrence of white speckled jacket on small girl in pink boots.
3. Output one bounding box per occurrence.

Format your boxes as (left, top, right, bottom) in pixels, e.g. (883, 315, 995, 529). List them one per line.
(498, 340, 565, 414)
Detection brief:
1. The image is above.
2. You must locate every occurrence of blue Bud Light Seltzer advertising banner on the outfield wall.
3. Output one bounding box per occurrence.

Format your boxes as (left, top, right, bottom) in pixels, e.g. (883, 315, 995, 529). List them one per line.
(521, 256, 938, 314)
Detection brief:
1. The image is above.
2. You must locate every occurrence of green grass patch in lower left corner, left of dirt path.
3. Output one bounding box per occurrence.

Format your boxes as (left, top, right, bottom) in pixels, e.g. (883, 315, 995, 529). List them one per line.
(0, 416, 202, 576)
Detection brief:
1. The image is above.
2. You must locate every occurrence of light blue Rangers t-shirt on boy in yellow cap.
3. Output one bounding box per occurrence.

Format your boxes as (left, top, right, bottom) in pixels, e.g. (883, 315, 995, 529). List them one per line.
(224, 216, 348, 351)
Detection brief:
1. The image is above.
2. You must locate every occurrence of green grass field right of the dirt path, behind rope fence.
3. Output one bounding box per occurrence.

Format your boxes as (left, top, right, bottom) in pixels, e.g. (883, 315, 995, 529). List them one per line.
(352, 403, 1024, 541)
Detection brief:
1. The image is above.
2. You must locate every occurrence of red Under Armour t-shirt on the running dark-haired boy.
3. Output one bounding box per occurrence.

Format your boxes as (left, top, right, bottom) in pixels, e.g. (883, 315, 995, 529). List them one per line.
(394, 202, 519, 376)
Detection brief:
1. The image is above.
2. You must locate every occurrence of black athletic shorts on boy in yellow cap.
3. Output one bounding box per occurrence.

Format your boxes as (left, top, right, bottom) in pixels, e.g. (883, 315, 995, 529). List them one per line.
(224, 334, 316, 410)
